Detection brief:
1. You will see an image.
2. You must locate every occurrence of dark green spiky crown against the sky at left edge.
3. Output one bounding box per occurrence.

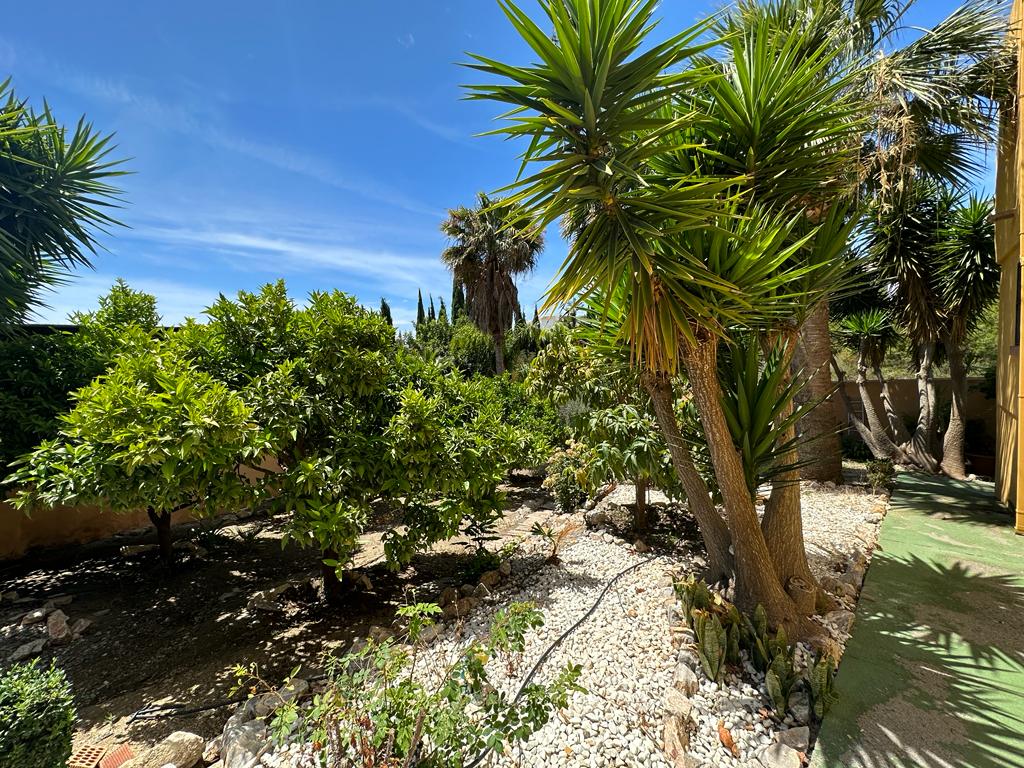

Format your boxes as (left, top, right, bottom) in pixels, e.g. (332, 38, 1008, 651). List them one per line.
(0, 80, 124, 328)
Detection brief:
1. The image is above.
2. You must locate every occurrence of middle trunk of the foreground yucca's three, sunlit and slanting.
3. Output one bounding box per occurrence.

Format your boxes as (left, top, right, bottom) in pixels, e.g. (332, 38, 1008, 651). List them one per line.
(684, 339, 804, 637)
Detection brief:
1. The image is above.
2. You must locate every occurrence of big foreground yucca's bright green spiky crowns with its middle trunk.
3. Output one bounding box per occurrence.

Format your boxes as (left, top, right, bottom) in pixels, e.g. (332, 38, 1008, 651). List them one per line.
(470, 0, 868, 630)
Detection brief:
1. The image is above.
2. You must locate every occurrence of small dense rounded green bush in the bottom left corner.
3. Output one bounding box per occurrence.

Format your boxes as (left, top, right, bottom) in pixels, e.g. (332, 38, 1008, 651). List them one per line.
(0, 662, 75, 768)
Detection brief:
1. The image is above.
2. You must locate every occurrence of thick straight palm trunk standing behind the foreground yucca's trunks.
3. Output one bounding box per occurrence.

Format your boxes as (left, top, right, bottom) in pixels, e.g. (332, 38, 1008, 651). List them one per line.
(795, 300, 843, 482)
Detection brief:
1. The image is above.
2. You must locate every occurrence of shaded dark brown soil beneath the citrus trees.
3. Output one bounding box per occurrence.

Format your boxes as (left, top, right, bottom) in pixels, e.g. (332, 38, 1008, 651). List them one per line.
(0, 476, 555, 757)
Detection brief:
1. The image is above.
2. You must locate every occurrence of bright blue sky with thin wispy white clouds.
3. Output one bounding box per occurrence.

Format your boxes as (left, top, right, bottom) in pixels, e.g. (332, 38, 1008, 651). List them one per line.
(0, 0, 987, 323)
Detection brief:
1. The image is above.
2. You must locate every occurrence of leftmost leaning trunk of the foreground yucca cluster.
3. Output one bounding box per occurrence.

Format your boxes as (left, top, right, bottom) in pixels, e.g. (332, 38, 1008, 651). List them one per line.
(641, 373, 732, 583)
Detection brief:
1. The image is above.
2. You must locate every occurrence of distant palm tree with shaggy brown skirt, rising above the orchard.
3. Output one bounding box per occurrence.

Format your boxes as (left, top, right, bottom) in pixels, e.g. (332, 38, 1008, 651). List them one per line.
(441, 193, 544, 375)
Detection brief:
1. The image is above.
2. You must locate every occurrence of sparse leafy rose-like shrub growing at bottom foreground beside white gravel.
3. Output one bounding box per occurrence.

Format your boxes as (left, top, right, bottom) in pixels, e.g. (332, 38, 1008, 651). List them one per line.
(236, 603, 582, 768)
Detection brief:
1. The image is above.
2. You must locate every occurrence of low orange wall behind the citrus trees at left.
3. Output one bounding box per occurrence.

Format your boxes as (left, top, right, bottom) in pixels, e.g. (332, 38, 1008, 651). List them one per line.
(0, 502, 193, 560)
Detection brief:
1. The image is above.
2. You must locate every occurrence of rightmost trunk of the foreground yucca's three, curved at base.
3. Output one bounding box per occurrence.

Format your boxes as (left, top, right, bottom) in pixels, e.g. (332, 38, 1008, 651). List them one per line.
(761, 338, 834, 613)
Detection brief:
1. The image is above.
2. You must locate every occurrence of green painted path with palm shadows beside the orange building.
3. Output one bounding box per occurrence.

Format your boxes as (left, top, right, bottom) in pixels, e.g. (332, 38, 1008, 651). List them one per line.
(811, 474, 1024, 768)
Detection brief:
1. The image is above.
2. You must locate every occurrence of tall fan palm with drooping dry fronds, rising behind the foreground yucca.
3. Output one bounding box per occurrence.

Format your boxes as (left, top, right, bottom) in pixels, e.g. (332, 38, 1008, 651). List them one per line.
(723, 0, 1013, 479)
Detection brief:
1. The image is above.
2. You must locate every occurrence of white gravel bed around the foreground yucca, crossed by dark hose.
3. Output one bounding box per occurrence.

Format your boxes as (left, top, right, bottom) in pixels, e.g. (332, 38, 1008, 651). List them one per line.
(251, 482, 885, 768)
